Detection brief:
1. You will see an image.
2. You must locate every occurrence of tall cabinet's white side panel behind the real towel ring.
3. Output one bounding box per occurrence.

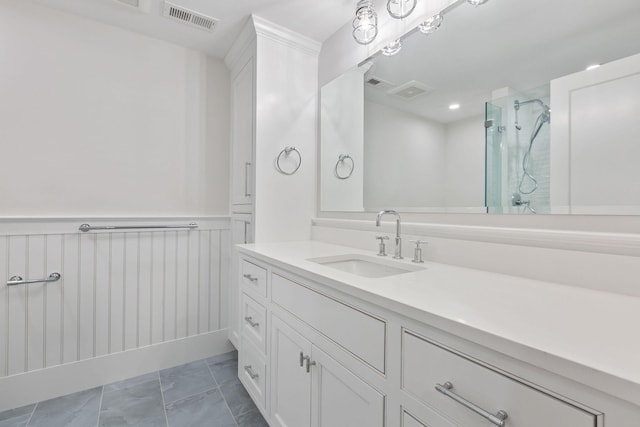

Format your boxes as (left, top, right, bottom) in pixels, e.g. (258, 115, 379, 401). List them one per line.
(253, 16, 320, 242)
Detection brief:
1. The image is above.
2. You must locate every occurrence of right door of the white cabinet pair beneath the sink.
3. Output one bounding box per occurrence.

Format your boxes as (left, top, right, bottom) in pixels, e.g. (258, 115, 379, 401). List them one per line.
(311, 346, 384, 427)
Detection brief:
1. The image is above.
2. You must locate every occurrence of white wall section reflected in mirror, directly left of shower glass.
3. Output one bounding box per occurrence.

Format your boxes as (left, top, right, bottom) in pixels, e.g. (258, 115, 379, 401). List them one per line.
(443, 115, 485, 208)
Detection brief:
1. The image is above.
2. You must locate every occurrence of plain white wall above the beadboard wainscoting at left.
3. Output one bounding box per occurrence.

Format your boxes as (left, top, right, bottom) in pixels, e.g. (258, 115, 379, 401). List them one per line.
(0, 0, 229, 216)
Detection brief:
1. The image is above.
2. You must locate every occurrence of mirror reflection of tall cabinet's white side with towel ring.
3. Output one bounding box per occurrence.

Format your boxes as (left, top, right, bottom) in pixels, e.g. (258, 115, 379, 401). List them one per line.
(319, 67, 366, 211)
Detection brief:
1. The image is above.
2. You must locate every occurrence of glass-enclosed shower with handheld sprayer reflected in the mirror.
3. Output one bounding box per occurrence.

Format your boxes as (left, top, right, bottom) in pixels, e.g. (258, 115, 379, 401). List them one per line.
(485, 85, 552, 214)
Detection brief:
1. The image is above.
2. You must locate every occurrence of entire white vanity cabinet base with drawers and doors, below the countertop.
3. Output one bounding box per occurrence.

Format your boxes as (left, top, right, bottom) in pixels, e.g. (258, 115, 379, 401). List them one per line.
(238, 248, 640, 427)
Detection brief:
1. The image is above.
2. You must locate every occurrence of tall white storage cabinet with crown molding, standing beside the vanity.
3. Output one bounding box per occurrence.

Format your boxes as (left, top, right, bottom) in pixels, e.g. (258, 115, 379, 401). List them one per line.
(225, 16, 320, 348)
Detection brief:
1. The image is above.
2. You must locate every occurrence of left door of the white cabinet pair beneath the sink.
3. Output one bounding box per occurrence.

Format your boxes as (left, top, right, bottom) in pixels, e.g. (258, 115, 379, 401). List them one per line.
(270, 316, 311, 427)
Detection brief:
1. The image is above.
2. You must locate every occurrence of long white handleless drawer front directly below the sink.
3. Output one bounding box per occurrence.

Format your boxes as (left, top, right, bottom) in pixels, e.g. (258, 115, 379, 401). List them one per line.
(271, 274, 386, 373)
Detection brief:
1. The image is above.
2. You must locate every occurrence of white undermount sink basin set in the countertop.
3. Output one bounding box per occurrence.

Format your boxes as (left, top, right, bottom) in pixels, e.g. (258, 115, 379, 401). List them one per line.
(307, 254, 424, 278)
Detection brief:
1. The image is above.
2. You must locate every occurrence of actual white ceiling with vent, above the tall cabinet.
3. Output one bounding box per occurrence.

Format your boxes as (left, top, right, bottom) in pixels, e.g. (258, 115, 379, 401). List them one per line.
(28, 0, 355, 58)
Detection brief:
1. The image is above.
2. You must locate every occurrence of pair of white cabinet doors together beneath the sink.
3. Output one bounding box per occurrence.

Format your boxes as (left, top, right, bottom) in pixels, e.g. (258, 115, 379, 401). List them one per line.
(270, 304, 384, 427)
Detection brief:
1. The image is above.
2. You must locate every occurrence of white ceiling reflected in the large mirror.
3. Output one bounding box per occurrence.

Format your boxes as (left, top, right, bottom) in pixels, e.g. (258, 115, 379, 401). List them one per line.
(366, 0, 640, 123)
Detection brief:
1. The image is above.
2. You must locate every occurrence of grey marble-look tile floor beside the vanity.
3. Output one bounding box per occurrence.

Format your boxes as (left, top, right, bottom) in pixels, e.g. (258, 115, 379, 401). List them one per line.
(0, 351, 268, 427)
